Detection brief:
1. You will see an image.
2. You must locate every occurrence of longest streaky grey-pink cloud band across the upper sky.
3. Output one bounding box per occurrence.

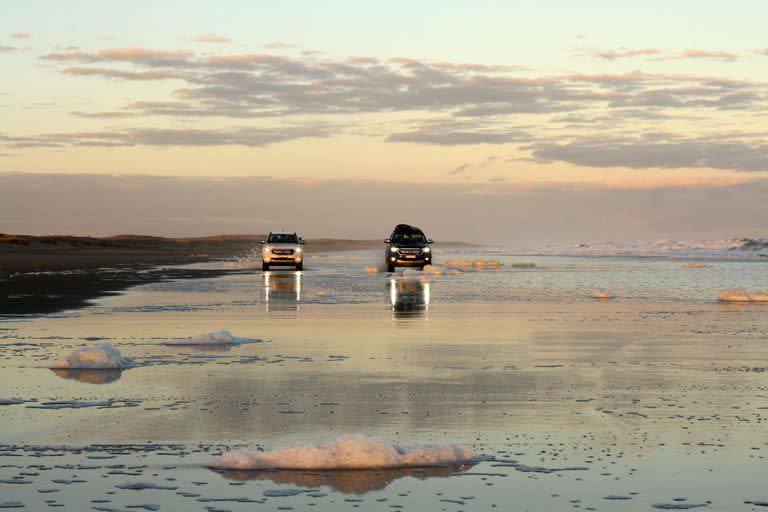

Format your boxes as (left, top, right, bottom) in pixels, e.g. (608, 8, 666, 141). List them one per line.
(37, 48, 766, 124)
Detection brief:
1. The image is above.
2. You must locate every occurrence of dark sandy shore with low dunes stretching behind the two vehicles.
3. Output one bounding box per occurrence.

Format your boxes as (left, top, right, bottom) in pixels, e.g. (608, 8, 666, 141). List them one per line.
(0, 234, 472, 317)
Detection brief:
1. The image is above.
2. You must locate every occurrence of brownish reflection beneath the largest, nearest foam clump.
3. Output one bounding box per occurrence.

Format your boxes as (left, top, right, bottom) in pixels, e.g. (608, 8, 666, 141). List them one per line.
(217, 464, 474, 494)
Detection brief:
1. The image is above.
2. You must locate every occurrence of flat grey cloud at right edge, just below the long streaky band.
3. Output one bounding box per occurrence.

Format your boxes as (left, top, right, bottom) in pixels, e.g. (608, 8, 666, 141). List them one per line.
(524, 134, 768, 171)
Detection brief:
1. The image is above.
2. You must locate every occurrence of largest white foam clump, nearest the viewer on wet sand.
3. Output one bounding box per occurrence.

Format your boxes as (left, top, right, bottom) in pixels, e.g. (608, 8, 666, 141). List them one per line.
(211, 434, 476, 470)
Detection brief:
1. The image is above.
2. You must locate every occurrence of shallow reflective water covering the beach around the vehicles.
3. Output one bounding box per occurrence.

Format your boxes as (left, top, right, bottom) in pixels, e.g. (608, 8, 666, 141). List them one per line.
(0, 251, 768, 511)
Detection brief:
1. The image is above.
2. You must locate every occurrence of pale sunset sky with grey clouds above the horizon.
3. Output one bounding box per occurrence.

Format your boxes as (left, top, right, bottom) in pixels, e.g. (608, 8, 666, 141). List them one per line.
(0, 0, 768, 245)
